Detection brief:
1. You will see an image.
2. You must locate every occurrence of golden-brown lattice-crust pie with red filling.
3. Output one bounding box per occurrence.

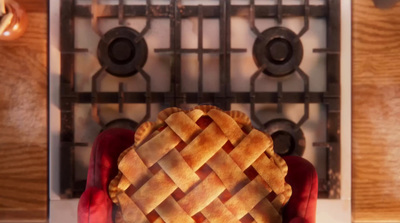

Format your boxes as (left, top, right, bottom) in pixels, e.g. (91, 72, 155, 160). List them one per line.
(109, 106, 292, 223)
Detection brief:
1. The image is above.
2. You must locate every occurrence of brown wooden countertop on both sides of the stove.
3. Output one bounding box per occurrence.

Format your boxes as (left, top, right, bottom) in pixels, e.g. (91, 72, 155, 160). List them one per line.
(0, 0, 400, 222)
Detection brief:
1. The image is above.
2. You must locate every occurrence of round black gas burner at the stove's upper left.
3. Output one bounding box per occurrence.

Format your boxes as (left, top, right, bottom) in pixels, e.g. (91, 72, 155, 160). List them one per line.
(97, 27, 147, 77)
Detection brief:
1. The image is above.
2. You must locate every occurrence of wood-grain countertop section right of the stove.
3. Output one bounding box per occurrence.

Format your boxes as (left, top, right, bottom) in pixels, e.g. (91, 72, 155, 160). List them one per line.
(352, 0, 400, 222)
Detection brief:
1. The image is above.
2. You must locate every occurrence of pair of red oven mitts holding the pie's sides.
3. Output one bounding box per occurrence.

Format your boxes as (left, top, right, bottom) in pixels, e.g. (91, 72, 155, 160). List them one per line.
(78, 129, 318, 223)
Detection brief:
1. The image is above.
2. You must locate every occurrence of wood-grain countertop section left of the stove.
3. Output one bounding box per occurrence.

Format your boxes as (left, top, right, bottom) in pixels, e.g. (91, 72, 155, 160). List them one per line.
(0, 0, 47, 222)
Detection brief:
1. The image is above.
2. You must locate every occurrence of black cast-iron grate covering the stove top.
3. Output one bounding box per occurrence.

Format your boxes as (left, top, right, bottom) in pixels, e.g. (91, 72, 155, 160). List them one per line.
(60, 0, 340, 199)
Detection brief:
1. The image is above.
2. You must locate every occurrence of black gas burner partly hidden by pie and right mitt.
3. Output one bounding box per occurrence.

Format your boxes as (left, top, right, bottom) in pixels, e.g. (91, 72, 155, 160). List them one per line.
(264, 119, 306, 156)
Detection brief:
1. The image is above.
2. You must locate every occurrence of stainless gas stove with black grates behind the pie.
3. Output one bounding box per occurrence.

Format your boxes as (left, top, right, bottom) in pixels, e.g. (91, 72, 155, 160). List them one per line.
(49, 0, 351, 222)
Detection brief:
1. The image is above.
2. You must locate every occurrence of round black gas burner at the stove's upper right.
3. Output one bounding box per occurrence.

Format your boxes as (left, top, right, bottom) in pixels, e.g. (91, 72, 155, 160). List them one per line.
(253, 27, 303, 77)
